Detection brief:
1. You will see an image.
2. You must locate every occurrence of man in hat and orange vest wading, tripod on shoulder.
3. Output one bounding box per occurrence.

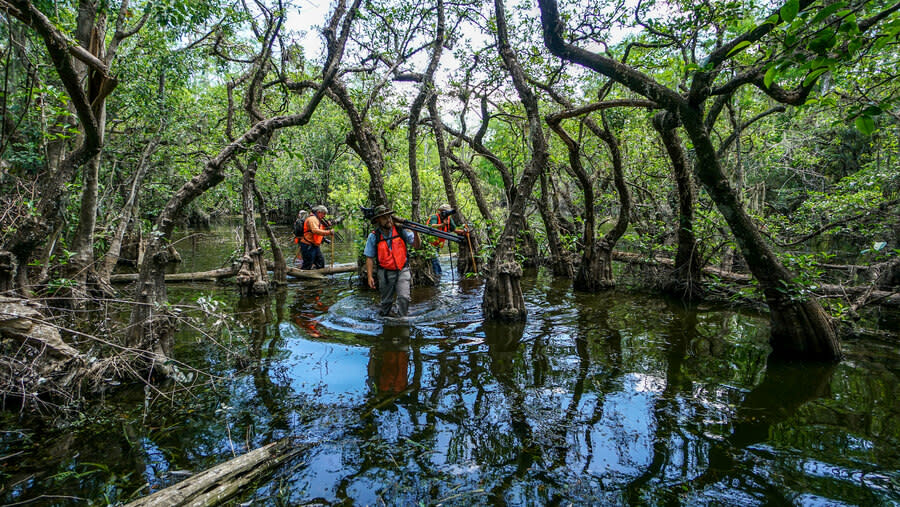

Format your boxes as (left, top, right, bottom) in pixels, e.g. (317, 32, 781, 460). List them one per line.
(363, 205, 415, 317)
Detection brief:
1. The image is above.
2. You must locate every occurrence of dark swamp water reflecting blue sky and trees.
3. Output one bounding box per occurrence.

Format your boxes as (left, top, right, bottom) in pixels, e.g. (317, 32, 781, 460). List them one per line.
(0, 227, 900, 505)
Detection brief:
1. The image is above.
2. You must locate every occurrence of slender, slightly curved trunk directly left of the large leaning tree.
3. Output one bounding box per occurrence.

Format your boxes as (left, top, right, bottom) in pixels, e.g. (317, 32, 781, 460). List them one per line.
(653, 112, 703, 301)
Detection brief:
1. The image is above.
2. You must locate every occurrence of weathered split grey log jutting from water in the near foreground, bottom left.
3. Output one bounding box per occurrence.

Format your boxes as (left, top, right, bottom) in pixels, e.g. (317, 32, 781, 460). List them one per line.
(127, 438, 308, 507)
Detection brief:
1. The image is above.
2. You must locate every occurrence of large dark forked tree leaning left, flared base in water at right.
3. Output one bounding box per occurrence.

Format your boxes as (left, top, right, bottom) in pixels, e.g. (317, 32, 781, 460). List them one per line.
(538, 0, 840, 360)
